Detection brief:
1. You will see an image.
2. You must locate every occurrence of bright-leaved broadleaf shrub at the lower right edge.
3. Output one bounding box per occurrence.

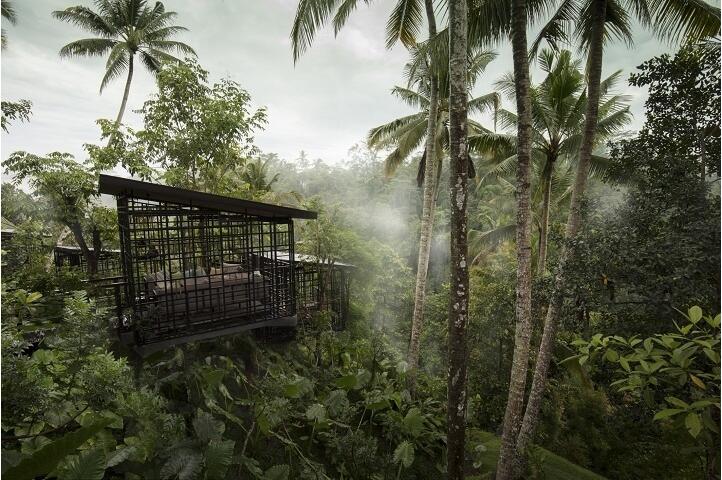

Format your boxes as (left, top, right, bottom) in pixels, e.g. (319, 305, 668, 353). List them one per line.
(564, 306, 720, 478)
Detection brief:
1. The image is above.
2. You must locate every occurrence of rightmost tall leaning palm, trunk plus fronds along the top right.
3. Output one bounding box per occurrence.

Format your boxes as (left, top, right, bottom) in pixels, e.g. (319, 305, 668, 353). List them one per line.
(516, 0, 720, 460)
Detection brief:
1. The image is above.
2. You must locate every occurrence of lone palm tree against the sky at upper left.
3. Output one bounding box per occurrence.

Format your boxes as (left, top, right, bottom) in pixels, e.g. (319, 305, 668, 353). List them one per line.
(53, 0, 195, 126)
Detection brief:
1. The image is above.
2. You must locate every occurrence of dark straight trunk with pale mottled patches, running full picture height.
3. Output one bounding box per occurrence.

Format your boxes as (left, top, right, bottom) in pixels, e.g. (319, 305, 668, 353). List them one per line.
(446, 0, 469, 480)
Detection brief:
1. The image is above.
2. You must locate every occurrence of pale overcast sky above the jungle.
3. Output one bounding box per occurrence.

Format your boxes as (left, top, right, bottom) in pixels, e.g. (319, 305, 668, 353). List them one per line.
(2, 0, 669, 163)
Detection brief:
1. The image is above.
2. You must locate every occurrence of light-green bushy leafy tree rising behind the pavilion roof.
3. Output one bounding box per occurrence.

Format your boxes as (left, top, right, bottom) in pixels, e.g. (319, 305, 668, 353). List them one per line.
(134, 59, 266, 194)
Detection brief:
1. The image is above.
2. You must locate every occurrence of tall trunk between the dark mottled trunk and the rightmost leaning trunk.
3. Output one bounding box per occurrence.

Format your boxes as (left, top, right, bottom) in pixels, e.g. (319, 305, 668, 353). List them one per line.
(496, 0, 532, 474)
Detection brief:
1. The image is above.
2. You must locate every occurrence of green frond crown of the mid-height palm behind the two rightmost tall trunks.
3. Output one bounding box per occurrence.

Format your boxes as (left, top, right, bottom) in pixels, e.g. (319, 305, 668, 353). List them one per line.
(469, 49, 631, 264)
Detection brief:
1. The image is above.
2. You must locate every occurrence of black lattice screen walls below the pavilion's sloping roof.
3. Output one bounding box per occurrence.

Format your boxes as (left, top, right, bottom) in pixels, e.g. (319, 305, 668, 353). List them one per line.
(118, 196, 296, 343)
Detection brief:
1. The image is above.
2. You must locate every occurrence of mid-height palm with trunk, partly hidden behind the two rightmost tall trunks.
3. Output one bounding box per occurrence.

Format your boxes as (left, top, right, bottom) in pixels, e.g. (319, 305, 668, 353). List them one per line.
(469, 50, 631, 275)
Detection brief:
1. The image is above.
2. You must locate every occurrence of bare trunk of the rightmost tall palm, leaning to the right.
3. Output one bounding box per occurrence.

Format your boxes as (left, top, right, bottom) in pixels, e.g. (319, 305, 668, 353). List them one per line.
(517, 0, 607, 450)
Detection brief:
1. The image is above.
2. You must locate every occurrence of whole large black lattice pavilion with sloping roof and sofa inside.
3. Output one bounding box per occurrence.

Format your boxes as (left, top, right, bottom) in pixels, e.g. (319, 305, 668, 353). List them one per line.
(99, 175, 316, 355)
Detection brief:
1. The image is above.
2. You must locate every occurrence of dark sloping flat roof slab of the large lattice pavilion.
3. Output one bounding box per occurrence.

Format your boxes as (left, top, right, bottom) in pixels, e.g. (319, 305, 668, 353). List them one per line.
(98, 175, 318, 219)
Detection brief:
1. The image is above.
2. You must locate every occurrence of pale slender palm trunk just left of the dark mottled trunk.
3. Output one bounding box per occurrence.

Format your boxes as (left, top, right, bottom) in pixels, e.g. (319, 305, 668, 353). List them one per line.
(407, 0, 439, 393)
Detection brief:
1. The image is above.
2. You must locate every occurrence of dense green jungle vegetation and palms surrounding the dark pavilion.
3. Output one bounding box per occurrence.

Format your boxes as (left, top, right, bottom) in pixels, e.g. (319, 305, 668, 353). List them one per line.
(1, 0, 721, 480)
